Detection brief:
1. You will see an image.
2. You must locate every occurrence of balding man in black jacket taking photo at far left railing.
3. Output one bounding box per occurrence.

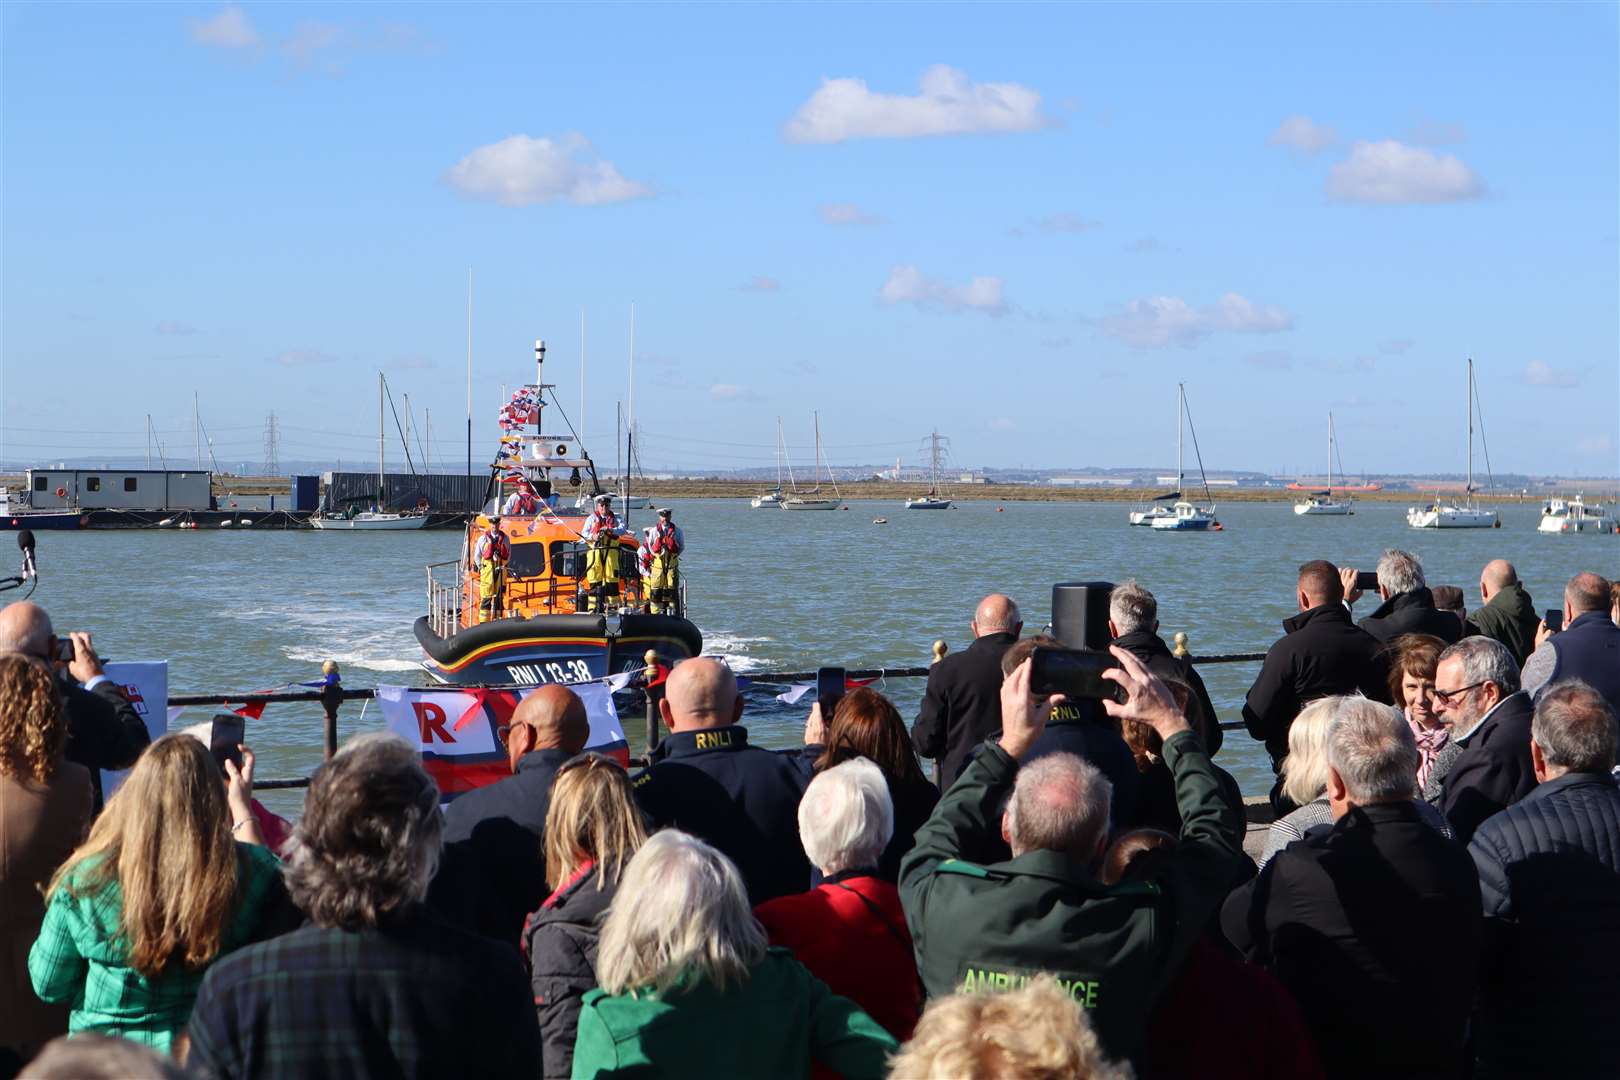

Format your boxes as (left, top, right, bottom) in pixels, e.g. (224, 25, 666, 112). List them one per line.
(0, 601, 151, 813)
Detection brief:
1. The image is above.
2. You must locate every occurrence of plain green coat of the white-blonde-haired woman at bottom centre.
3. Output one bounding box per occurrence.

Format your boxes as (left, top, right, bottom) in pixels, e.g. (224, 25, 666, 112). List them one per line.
(573, 949, 897, 1080)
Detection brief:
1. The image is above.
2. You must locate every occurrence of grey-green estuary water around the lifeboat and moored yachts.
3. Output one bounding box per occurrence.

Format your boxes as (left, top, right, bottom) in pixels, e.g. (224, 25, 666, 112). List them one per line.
(25, 500, 1620, 813)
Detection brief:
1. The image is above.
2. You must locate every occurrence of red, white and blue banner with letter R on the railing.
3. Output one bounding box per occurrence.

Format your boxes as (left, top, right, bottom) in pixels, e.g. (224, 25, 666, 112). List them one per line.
(377, 683, 630, 801)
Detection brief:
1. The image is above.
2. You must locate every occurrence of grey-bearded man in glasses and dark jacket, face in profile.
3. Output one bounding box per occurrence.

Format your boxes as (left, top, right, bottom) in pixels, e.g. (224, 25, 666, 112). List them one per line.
(1426, 638, 1536, 844)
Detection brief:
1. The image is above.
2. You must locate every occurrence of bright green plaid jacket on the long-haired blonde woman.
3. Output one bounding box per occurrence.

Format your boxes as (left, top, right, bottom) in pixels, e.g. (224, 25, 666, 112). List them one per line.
(28, 844, 290, 1051)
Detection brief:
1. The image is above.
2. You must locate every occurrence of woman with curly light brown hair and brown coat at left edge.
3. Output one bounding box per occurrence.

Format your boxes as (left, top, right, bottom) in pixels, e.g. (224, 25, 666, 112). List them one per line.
(0, 656, 92, 1061)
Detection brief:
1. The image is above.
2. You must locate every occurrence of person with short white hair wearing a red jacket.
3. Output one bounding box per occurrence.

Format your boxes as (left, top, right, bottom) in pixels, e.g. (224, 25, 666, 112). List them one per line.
(753, 758, 922, 1041)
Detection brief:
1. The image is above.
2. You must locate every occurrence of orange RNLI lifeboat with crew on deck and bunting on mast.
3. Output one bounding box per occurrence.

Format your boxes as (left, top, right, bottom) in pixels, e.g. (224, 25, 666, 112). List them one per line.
(415, 342, 703, 685)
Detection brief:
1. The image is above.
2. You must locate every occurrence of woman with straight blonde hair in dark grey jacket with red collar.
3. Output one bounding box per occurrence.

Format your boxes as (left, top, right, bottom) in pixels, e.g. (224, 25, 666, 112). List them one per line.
(523, 753, 646, 1080)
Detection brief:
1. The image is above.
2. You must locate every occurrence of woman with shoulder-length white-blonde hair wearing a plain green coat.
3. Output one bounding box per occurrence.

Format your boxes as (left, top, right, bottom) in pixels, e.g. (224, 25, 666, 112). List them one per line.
(573, 829, 896, 1078)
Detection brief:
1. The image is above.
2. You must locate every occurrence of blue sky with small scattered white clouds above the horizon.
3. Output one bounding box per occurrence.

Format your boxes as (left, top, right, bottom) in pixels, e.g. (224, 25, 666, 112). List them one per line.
(0, 3, 1620, 474)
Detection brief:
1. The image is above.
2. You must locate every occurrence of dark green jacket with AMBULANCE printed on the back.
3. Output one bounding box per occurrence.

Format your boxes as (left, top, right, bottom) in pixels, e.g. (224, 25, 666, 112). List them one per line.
(901, 732, 1246, 1057)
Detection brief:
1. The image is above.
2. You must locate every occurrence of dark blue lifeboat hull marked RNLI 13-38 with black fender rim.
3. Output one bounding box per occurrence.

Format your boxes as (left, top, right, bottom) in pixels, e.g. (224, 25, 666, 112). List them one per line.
(415, 614, 703, 687)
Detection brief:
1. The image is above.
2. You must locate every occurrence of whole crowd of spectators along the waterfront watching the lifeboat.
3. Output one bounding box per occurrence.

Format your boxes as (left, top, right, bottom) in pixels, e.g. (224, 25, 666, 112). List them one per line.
(0, 551, 1620, 1080)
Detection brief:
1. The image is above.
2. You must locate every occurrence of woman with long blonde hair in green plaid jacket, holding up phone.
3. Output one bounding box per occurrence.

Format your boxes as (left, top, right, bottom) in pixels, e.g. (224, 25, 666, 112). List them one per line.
(28, 735, 292, 1049)
